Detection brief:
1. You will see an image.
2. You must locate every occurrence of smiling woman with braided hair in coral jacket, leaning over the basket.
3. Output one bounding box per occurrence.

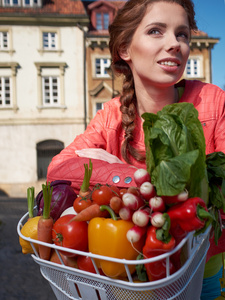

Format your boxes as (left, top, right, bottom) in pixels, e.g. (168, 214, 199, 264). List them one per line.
(47, 0, 225, 300)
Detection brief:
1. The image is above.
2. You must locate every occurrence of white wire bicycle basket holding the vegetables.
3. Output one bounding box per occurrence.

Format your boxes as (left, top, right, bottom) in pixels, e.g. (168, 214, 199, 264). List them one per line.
(17, 213, 210, 300)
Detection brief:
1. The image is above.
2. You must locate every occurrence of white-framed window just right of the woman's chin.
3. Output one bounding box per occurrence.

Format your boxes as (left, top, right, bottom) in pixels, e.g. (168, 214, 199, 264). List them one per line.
(185, 56, 203, 78)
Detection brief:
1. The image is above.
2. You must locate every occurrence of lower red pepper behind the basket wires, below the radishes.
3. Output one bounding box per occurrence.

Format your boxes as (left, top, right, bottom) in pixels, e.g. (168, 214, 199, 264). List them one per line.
(143, 226, 176, 281)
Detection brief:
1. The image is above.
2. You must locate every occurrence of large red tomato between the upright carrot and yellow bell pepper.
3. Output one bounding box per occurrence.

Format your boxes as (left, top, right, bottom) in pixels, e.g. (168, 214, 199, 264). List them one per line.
(52, 215, 88, 257)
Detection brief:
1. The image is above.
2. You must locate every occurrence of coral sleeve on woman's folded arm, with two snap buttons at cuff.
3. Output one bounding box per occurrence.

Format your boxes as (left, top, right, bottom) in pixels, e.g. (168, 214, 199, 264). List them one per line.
(47, 103, 136, 193)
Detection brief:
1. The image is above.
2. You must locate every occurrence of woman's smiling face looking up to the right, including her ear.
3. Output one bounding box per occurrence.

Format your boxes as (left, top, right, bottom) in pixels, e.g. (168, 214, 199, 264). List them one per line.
(121, 2, 190, 87)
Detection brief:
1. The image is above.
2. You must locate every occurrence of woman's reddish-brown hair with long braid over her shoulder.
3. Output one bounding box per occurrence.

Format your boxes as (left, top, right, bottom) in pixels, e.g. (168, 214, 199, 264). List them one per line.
(109, 0, 197, 163)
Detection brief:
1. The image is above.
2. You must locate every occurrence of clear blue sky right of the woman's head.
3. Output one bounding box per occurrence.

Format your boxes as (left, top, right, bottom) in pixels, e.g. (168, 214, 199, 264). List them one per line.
(193, 0, 225, 88)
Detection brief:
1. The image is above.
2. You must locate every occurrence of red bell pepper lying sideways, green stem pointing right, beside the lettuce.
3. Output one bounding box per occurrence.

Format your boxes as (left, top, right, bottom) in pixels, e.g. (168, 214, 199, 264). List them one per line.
(167, 197, 212, 232)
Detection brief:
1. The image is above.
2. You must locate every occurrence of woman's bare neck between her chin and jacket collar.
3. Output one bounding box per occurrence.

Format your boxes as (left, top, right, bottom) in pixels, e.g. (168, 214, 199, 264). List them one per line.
(136, 86, 179, 116)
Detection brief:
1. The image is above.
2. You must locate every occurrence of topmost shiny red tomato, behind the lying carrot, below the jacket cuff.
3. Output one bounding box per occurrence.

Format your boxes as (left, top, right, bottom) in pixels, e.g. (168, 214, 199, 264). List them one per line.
(92, 185, 115, 205)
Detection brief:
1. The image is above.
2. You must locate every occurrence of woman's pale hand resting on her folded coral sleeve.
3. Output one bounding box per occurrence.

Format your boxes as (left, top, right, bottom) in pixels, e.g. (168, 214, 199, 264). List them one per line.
(75, 148, 123, 164)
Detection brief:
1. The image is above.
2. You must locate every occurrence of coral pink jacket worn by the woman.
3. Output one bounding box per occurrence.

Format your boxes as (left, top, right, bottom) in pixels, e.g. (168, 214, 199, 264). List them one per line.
(47, 80, 225, 260)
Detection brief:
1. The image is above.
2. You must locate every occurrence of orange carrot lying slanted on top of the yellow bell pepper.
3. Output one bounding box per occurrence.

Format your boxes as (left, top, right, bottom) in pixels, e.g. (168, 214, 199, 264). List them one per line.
(70, 203, 108, 222)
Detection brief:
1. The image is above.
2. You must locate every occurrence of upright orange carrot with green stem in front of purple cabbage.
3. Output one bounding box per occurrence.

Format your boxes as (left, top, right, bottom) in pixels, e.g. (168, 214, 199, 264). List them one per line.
(38, 183, 53, 260)
